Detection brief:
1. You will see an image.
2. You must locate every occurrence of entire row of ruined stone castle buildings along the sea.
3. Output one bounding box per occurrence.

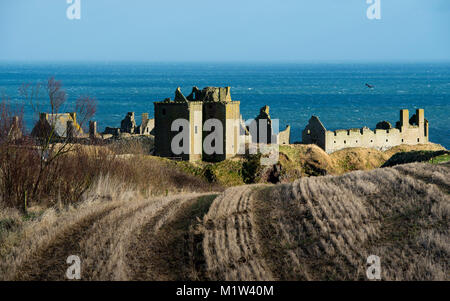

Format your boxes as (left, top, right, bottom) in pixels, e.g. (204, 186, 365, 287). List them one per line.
(28, 91, 429, 162)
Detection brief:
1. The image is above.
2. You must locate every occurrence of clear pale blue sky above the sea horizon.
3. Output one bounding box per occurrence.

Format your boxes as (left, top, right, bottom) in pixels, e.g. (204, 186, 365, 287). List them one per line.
(0, 0, 450, 62)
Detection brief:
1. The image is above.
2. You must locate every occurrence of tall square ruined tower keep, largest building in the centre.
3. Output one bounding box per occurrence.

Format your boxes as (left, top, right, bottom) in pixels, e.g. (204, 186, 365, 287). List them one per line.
(154, 87, 242, 162)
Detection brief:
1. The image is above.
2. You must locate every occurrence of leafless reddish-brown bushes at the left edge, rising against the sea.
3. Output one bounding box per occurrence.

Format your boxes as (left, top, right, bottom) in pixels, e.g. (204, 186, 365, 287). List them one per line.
(0, 78, 95, 212)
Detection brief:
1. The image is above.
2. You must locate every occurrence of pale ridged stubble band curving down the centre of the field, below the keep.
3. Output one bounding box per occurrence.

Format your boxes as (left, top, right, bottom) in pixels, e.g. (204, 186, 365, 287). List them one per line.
(203, 186, 273, 281)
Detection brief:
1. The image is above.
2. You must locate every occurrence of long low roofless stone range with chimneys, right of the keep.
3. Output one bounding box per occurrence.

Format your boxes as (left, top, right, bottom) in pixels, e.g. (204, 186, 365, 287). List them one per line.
(302, 109, 429, 153)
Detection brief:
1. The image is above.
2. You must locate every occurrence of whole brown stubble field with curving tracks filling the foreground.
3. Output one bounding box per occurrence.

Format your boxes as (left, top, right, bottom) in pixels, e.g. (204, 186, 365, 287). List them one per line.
(0, 163, 450, 280)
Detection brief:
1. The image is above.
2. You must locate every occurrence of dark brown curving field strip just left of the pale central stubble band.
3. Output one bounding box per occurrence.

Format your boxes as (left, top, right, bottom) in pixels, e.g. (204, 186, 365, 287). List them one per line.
(129, 194, 216, 281)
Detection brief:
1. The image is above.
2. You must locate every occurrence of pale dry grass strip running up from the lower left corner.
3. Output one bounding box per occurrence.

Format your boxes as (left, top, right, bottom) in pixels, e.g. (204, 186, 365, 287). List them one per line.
(0, 176, 126, 280)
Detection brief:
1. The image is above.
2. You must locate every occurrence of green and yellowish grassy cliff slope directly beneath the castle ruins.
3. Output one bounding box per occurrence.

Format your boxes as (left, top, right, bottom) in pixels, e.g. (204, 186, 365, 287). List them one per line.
(166, 143, 450, 187)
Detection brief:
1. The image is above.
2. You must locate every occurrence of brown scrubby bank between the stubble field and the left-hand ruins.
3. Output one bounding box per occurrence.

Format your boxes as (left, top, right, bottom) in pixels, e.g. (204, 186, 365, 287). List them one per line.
(0, 145, 221, 213)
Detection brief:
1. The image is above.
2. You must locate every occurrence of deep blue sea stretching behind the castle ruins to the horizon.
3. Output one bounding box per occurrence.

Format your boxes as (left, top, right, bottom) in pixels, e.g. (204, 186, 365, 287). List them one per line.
(0, 63, 450, 148)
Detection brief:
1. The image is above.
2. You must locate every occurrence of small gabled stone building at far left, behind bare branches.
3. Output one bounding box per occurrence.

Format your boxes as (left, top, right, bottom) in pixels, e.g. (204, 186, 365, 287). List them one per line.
(31, 112, 84, 139)
